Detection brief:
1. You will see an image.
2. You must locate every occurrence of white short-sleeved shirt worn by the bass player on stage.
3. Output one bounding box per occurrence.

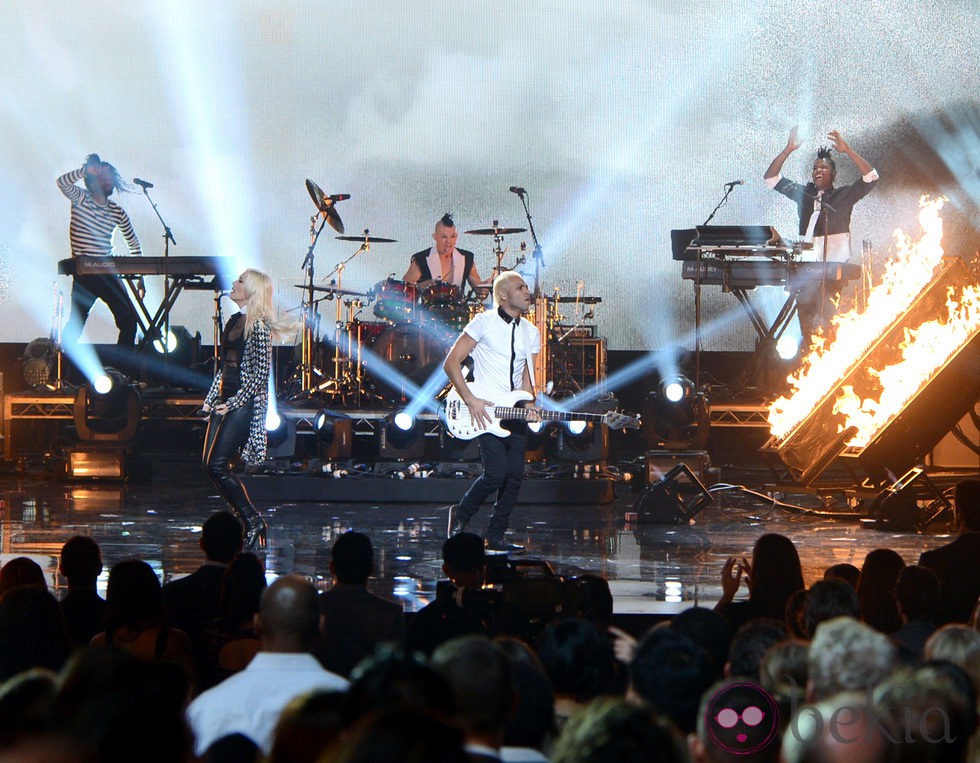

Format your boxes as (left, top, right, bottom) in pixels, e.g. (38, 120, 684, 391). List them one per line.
(463, 307, 541, 393)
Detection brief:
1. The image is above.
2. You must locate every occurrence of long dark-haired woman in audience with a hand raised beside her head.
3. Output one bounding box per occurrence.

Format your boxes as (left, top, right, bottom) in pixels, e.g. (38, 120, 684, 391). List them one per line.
(715, 533, 805, 633)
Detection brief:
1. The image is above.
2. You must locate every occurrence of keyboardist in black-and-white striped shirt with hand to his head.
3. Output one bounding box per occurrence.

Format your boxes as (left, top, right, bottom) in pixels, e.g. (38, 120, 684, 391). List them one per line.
(58, 154, 142, 346)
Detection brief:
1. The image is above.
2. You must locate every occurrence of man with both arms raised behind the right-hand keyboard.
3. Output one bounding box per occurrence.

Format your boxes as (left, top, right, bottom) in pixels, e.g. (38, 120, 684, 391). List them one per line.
(765, 127, 878, 341)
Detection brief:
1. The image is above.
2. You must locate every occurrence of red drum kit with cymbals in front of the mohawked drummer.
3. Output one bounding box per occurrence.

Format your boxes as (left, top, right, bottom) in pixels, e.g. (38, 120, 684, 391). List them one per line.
(295, 180, 525, 406)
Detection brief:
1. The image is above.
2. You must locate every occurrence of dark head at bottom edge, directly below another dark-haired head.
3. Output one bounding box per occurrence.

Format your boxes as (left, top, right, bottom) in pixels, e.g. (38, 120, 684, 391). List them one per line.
(330, 707, 470, 763)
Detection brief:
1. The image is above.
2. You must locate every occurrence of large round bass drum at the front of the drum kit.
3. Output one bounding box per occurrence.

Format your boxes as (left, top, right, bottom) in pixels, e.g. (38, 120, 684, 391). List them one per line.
(368, 323, 445, 402)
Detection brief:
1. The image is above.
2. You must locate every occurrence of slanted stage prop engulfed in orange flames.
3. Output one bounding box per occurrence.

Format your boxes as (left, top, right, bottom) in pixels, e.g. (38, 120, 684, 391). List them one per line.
(763, 199, 980, 485)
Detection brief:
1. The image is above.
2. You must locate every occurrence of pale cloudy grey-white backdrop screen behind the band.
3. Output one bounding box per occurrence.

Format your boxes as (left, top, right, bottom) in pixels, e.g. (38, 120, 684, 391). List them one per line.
(0, 0, 980, 349)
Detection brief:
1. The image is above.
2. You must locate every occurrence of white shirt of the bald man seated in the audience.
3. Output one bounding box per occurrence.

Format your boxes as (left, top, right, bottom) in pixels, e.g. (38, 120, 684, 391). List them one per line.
(187, 652, 349, 755)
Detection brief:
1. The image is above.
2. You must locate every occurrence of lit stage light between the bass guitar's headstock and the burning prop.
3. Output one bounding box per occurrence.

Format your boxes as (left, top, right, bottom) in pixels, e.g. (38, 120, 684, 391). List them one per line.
(642, 375, 709, 448)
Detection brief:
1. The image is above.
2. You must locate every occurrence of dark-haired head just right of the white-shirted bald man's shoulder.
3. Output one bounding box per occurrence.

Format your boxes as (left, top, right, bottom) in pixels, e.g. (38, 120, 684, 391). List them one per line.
(344, 644, 453, 727)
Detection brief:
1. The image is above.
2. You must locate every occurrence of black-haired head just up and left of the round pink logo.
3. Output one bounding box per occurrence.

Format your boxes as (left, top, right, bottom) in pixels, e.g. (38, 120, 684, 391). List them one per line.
(629, 628, 715, 734)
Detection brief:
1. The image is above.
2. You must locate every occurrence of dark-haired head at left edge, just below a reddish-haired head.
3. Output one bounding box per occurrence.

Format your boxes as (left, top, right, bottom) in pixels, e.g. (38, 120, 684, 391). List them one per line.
(0, 586, 71, 681)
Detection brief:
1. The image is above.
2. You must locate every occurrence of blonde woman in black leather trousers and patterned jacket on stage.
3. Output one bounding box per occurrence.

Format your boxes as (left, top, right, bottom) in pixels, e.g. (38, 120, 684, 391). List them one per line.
(202, 268, 291, 549)
